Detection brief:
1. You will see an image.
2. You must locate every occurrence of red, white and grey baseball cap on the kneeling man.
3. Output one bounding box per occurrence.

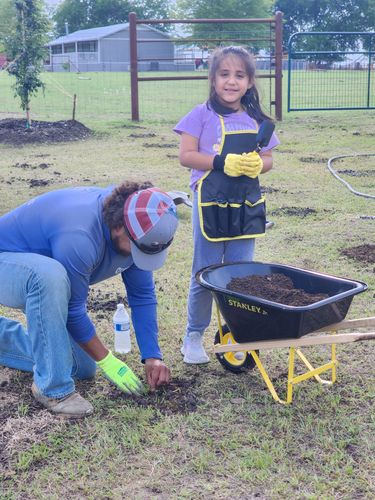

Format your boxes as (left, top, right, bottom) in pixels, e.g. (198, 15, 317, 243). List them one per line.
(124, 187, 178, 271)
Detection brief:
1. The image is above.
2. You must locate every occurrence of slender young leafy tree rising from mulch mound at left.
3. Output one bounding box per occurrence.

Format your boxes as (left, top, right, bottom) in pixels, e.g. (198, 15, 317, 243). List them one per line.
(5, 0, 50, 127)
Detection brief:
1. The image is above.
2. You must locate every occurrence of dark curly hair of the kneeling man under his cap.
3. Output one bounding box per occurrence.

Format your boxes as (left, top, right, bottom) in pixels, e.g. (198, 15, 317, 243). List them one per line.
(103, 181, 153, 229)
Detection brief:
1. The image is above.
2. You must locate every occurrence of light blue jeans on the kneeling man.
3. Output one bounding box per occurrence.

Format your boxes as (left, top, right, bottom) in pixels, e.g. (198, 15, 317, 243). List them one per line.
(0, 252, 96, 398)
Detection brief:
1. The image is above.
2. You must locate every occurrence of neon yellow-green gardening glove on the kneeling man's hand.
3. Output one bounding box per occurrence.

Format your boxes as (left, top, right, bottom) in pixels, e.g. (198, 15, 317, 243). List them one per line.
(97, 351, 144, 394)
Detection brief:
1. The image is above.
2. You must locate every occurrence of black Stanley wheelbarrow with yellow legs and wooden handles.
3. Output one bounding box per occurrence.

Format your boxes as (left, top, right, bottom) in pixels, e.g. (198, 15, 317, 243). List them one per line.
(196, 262, 375, 403)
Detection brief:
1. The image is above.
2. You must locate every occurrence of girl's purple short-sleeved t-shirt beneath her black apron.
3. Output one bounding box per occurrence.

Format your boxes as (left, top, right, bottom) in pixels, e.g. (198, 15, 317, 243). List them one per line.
(173, 103, 280, 190)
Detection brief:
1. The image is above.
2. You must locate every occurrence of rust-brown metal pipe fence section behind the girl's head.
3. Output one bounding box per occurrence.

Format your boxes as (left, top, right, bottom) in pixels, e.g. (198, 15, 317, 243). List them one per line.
(129, 12, 282, 120)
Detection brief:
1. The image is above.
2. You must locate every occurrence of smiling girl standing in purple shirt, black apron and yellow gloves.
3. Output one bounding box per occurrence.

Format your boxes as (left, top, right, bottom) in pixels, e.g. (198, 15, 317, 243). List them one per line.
(174, 46, 279, 364)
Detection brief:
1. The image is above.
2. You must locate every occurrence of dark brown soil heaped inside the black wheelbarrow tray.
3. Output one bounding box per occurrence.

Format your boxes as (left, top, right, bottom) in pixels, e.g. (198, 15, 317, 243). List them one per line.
(227, 273, 329, 307)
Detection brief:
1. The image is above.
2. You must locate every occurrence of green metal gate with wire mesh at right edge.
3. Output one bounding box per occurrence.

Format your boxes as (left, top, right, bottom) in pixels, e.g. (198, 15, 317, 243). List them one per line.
(288, 32, 375, 111)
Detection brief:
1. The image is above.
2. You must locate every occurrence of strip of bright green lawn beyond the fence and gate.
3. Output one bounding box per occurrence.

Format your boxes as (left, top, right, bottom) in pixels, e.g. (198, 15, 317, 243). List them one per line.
(0, 70, 375, 122)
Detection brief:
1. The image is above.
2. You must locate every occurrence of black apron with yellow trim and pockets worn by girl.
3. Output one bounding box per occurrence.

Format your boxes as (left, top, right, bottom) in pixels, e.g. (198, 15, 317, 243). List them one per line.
(197, 116, 266, 241)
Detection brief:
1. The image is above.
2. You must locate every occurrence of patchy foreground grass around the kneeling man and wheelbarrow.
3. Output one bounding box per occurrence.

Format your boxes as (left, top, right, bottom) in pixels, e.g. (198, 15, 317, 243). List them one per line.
(0, 100, 375, 500)
